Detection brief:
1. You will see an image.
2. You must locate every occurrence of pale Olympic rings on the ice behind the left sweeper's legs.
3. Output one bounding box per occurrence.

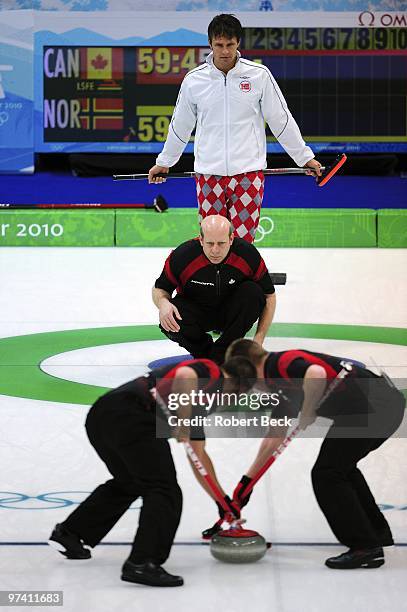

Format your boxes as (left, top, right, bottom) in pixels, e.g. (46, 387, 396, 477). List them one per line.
(0, 491, 142, 510)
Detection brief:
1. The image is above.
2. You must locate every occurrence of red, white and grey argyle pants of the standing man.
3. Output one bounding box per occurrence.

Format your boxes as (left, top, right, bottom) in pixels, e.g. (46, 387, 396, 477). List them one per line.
(195, 171, 264, 242)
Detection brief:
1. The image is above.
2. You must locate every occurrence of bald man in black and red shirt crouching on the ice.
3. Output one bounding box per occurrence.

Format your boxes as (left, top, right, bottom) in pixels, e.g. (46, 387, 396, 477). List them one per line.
(152, 215, 276, 364)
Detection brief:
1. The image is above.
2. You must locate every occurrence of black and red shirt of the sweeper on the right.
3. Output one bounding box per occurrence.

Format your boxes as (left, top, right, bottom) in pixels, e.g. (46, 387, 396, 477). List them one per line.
(264, 349, 378, 417)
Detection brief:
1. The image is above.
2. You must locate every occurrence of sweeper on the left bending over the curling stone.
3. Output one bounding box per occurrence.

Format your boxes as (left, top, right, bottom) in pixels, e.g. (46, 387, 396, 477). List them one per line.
(49, 357, 255, 587)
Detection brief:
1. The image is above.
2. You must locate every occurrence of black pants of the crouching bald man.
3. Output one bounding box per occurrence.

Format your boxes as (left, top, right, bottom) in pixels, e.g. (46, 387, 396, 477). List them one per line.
(160, 281, 266, 363)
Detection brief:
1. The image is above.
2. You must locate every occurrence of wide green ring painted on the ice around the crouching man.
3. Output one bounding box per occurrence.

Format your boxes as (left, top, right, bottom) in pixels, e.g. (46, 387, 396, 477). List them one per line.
(0, 323, 407, 405)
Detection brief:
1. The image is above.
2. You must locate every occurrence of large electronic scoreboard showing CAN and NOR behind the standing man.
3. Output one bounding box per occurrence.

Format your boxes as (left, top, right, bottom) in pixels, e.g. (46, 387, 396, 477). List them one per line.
(41, 28, 407, 153)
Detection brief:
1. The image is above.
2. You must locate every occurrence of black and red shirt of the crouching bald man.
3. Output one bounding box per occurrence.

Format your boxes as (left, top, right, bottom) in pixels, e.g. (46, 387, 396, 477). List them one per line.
(155, 238, 275, 308)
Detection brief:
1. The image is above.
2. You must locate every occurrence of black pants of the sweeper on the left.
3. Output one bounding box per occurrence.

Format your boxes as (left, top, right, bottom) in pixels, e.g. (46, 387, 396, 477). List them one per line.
(63, 383, 182, 565)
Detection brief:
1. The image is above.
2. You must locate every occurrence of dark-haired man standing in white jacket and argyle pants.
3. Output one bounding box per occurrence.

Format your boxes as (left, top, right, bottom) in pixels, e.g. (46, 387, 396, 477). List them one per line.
(149, 14, 321, 242)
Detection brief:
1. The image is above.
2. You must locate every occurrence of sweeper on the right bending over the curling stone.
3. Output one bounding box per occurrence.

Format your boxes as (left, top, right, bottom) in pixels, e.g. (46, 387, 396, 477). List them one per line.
(227, 340, 405, 569)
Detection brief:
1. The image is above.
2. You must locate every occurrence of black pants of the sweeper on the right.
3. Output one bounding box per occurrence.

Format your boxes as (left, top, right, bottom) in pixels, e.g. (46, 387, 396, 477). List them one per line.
(311, 381, 405, 549)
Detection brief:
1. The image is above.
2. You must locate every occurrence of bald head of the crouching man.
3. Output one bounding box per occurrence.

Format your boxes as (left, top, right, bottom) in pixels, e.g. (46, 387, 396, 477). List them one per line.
(200, 215, 233, 264)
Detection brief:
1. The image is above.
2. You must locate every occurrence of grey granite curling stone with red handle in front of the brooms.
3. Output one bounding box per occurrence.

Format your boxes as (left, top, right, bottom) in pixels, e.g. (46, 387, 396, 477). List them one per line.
(210, 528, 267, 563)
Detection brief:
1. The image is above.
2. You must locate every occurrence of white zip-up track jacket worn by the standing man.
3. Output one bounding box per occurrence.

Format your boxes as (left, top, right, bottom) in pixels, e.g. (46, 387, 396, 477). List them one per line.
(156, 53, 314, 176)
